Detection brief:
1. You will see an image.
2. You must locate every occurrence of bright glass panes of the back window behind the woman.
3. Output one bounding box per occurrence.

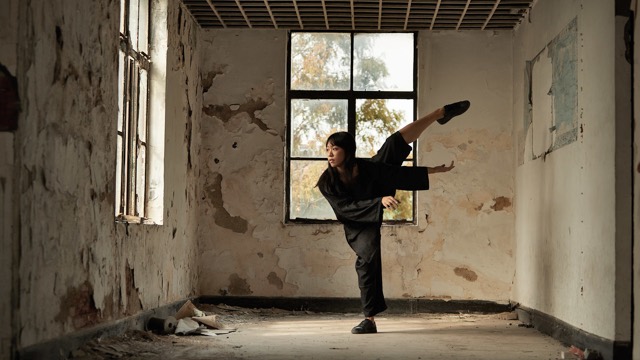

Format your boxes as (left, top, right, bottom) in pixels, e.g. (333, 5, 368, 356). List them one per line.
(286, 32, 416, 223)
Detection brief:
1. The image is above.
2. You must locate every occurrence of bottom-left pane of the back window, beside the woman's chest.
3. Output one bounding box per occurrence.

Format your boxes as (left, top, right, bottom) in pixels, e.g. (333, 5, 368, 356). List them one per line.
(289, 160, 336, 220)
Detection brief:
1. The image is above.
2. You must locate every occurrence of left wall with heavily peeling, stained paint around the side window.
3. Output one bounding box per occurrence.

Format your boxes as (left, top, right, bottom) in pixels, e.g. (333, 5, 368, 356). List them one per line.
(15, 0, 202, 347)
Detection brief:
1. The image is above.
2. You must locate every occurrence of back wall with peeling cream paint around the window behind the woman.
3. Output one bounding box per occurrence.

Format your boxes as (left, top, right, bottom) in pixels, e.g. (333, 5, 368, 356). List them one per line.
(198, 30, 514, 301)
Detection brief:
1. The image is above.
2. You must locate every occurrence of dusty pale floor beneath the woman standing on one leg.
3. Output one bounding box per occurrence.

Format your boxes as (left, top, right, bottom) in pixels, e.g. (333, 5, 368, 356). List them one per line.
(71, 307, 573, 360)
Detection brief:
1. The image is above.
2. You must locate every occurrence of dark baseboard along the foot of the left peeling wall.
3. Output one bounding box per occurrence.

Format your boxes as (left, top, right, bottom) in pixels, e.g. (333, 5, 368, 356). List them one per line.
(18, 298, 194, 360)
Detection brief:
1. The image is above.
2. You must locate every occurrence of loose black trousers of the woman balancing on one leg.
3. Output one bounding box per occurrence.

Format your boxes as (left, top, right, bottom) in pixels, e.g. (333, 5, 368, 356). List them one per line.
(356, 132, 411, 317)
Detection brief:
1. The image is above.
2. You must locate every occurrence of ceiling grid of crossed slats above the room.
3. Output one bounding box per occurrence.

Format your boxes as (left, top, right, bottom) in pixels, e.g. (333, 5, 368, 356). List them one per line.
(181, 0, 535, 31)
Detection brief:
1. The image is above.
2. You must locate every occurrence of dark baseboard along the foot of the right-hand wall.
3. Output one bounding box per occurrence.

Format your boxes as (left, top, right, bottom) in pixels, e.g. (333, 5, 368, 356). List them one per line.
(516, 307, 632, 360)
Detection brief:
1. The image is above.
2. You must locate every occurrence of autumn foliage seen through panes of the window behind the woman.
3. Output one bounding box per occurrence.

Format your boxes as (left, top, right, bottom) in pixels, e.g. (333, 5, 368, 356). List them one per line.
(290, 33, 413, 220)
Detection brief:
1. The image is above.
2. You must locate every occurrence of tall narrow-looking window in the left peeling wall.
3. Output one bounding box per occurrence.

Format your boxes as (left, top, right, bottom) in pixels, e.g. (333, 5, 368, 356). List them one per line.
(115, 0, 150, 222)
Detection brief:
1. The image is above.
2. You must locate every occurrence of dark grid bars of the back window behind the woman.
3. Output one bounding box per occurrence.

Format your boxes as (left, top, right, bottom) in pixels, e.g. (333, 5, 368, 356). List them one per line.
(285, 31, 417, 224)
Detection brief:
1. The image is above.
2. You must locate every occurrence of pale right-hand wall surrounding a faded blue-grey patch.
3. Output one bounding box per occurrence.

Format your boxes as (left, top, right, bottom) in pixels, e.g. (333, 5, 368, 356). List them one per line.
(513, 0, 630, 341)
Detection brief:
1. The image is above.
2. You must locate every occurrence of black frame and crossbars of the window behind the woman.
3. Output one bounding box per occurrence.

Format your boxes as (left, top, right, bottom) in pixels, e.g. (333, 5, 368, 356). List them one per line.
(284, 30, 418, 225)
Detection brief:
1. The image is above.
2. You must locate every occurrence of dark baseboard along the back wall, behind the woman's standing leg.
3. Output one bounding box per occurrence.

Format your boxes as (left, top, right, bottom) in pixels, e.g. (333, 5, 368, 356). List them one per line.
(197, 296, 510, 314)
